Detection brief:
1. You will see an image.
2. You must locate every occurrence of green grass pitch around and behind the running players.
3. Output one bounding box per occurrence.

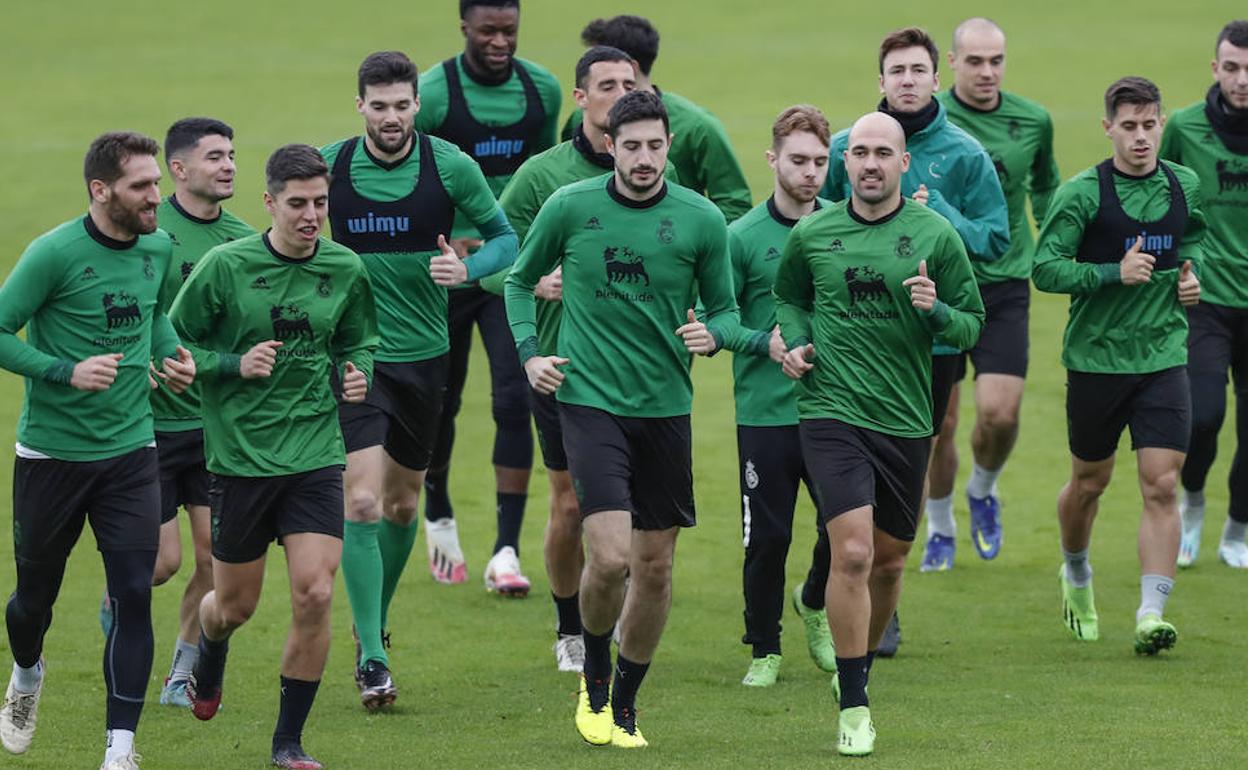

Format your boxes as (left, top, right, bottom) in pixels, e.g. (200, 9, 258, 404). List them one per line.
(0, 0, 1248, 769)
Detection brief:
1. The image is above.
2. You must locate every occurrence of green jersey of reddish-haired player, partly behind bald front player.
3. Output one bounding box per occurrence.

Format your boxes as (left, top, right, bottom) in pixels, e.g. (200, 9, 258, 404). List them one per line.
(728, 198, 830, 427)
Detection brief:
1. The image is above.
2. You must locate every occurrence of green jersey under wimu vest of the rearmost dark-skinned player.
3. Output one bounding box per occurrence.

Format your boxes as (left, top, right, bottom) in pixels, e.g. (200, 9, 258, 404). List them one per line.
(416, 55, 563, 238)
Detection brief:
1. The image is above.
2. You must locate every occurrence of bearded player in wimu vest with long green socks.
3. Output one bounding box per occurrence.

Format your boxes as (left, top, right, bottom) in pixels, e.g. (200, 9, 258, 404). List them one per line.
(322, 51, 517, 710)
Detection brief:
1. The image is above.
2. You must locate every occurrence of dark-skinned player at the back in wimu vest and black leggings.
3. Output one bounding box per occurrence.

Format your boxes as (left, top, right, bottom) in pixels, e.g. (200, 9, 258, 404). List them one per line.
(416, 0, 562, 597)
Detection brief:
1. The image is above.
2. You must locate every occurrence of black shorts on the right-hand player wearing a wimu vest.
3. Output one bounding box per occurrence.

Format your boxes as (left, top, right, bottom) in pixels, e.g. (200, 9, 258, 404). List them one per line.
(1066, 367, 1192, 463)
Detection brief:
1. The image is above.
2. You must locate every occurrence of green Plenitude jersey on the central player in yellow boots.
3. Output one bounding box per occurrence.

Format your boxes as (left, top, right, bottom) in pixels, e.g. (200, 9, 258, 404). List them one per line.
(505, 175, 740, 417)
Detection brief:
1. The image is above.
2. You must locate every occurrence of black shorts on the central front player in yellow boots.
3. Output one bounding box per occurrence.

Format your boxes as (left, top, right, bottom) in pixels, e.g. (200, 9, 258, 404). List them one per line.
(559, 403, 696, 529)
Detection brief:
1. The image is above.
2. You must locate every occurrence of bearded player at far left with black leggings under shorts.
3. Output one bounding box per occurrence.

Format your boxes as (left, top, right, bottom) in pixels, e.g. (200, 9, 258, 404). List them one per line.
(0, 132, 195, 770)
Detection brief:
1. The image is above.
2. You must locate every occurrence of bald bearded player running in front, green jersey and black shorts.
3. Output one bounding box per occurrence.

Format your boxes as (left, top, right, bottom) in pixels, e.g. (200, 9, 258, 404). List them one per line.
(775, 112, 983, 756)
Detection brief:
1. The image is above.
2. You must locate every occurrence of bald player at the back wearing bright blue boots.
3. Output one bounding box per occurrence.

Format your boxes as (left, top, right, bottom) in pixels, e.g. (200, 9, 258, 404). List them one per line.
(920, 19, 1062, 572)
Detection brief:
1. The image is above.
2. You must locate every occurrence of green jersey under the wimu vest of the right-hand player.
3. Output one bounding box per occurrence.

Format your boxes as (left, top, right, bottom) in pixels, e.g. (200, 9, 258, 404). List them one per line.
(1032, 161, 1206, 374)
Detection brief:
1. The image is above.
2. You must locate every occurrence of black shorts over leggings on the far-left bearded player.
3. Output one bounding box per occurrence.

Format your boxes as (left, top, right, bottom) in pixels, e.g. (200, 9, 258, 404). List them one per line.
(12, 447, 160, 564)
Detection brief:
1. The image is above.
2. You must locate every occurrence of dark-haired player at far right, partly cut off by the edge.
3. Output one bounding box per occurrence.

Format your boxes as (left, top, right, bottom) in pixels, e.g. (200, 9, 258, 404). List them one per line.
(1161, 20, 1248, 569)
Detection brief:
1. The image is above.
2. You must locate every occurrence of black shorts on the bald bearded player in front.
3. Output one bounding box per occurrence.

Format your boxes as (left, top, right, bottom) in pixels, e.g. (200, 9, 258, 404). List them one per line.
(799, 419, 931, 542)
